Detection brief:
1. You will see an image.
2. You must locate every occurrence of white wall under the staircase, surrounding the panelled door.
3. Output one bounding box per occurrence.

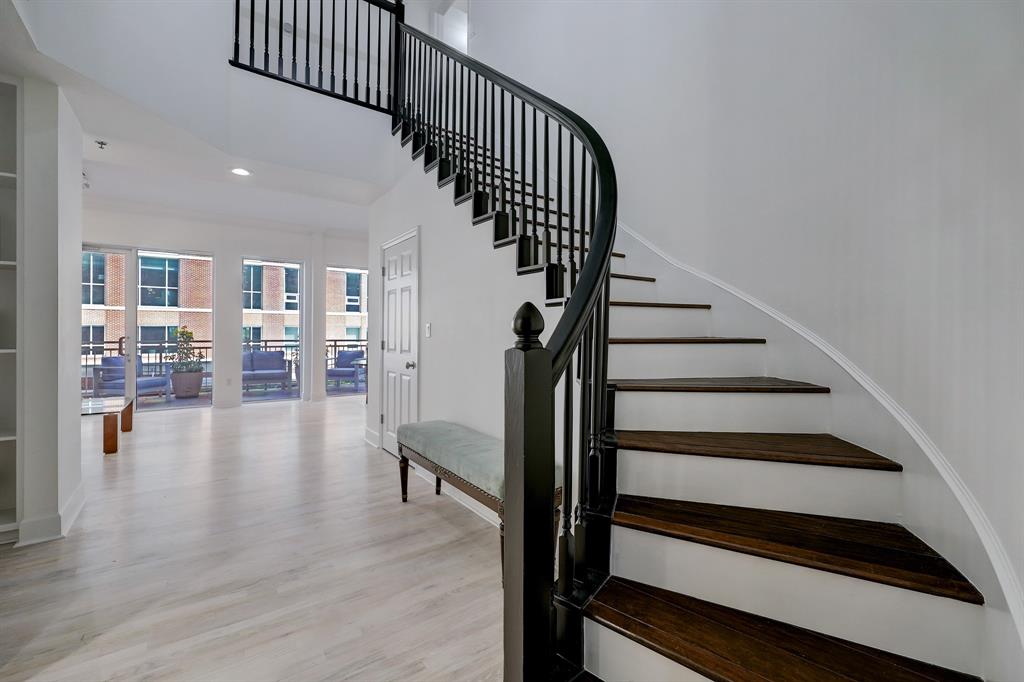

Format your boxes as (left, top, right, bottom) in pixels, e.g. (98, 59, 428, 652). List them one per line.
(367, 152, 557, 444)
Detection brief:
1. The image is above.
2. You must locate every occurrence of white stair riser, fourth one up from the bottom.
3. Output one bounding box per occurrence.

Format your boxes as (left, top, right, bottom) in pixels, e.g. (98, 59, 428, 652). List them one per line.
(612, 387, 830, 433)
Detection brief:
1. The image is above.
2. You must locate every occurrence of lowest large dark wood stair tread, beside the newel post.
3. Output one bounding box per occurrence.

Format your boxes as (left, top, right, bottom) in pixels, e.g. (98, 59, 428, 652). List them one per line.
(585, 577, 979, 682)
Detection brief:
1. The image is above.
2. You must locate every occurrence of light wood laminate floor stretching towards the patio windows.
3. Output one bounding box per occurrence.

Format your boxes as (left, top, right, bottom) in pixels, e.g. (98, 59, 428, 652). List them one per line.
(0, 396, 502, 682)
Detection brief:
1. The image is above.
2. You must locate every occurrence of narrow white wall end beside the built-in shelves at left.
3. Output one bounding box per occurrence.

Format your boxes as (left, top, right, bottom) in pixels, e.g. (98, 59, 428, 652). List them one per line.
(18, 79, 84, 544)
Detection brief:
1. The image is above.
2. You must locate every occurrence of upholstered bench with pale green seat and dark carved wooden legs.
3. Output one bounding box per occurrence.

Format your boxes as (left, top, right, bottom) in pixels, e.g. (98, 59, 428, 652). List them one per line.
(398, 421, 562, 569)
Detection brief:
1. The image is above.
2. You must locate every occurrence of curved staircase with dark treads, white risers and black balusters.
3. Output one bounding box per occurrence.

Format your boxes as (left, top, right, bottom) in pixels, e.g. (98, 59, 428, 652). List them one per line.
(232, 0, 984, 682)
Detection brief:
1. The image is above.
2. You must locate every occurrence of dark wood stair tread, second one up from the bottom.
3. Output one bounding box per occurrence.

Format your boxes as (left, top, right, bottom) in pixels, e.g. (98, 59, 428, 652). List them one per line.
(612, 495, 984, 604)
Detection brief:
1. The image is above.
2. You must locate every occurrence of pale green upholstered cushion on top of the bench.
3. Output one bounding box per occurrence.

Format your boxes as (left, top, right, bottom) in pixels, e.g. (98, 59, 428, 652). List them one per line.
(398, 421, 562, 500)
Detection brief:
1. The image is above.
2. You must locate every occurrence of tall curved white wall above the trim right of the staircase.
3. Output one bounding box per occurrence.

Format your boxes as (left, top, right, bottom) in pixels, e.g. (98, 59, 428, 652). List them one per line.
(470, 0, 1024, 667)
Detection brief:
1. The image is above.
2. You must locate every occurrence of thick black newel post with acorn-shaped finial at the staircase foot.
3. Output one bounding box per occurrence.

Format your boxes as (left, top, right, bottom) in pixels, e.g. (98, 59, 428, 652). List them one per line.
(505, 302, 555, 682)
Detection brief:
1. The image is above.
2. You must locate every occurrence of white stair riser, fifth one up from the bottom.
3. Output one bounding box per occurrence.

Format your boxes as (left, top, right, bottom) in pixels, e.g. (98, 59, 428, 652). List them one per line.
(608, 342, 765, 379)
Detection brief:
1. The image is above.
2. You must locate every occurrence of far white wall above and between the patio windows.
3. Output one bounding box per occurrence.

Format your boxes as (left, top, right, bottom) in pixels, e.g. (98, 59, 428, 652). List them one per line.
(83, 201, 367, 408)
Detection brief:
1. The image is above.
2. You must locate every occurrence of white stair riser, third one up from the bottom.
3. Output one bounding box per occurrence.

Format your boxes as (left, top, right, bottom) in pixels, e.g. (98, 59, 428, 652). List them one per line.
(616, 450, 900, 522)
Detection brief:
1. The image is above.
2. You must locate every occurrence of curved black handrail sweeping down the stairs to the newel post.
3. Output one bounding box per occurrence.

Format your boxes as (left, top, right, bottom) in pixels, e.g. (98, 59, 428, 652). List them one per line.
(399, 24, 618, 378)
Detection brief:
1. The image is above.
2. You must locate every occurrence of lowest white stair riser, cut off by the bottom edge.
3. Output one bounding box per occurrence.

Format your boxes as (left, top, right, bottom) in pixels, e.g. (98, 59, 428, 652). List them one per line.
(583, 619, 708, 682)
